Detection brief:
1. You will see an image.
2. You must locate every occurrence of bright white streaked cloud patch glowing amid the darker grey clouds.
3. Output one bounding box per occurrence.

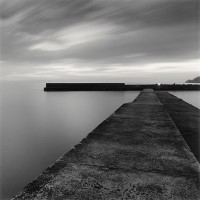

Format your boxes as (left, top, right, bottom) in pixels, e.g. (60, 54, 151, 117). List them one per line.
(29, 21, 118, 51)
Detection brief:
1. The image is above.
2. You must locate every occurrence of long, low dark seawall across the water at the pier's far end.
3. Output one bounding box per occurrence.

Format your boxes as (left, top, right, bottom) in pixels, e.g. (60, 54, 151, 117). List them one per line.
(44, 83, 200, 91)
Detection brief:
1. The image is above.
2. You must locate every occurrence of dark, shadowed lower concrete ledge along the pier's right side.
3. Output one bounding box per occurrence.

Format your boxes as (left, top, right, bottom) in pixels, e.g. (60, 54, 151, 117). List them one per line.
(156, 91, 200, 162)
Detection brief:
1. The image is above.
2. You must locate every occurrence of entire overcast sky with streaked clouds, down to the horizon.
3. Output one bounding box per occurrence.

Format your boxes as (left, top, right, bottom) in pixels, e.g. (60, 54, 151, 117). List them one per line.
(0, 0, 200, 83)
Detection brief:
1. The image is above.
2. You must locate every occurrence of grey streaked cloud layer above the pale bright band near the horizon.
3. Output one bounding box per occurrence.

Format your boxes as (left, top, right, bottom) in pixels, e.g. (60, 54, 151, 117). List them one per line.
(0, 0, 199, 81)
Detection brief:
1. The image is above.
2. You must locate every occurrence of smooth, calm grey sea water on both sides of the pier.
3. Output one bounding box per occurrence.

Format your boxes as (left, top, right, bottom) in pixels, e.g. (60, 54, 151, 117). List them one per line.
(0, 82, 199, 200)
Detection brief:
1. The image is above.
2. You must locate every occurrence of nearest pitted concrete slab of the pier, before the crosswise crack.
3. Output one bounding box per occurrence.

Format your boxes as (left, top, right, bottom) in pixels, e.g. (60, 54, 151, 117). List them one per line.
(15, 164, 198, 200)
